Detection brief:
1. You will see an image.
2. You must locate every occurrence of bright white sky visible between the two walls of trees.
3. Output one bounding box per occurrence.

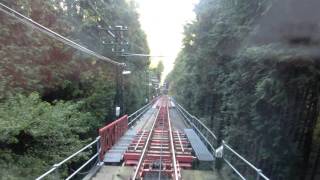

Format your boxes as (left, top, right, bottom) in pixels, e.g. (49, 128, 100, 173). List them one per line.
(135, 0, 198, 81)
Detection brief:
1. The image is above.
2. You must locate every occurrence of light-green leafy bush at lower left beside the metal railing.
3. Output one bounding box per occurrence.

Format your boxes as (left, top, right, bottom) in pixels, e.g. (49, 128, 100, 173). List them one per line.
(0, 93, 94, 179)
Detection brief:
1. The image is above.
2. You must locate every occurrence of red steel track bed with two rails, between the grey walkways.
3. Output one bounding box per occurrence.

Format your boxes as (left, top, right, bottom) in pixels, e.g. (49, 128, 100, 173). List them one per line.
(124, 97, 195, 179)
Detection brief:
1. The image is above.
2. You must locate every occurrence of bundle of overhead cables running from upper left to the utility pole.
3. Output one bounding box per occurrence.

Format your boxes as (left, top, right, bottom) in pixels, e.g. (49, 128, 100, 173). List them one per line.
(0, 3, 125, 66)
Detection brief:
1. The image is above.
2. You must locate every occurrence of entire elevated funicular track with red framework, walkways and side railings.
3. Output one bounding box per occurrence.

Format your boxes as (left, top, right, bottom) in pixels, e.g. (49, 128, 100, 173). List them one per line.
(37, 96, 269, 180)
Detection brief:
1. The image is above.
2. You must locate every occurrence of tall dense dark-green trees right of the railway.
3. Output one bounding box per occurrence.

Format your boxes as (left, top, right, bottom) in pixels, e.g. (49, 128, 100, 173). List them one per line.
(167, 0, 320, 180)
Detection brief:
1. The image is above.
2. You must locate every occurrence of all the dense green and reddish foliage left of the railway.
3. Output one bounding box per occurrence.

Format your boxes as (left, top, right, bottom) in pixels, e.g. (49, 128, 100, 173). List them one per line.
(0, 0, 150, 179)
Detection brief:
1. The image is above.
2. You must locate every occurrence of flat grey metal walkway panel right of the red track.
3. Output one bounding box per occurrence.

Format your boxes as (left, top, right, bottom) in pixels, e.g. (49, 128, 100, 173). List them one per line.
(184, 129, 214, 161)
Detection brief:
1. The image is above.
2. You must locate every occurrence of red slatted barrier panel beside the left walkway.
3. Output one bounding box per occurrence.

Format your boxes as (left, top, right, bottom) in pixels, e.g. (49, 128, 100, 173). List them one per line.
(99, 115, 128, 161)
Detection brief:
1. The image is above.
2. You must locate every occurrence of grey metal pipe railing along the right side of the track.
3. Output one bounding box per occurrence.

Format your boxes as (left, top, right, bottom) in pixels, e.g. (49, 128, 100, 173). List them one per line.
(171, 98, 269, 180)
